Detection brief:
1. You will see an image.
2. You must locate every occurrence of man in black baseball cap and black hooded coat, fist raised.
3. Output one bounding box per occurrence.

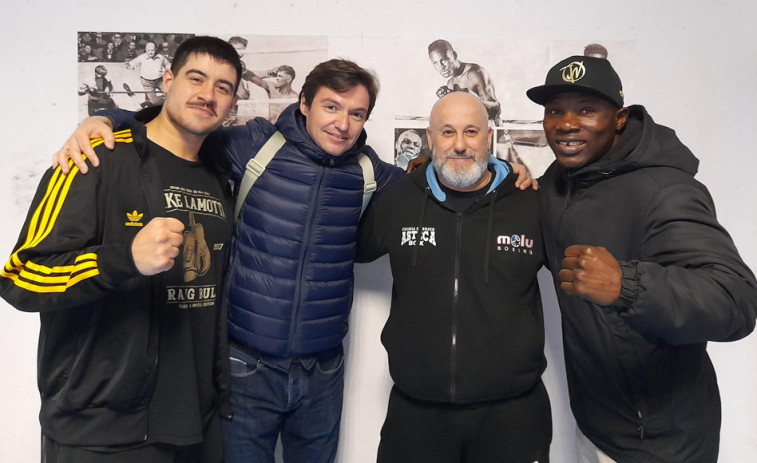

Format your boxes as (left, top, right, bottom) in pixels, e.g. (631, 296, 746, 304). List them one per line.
(527, 56, 757, 463)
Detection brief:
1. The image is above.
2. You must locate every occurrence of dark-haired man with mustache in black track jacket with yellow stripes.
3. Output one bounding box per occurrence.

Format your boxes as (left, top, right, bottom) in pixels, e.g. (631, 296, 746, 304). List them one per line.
(0, 37, 242, 463)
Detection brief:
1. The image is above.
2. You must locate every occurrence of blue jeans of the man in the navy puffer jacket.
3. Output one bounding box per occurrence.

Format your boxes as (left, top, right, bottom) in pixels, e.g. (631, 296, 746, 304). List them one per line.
(223, 345, 344, 463)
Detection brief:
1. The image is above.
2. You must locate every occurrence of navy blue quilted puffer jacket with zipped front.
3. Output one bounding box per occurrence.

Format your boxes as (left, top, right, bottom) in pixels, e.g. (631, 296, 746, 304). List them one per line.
(206, 104, 402, 357)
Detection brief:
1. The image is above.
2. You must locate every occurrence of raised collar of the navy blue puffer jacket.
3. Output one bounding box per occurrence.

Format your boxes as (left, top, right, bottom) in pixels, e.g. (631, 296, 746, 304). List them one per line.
(276, 103, 368, 167)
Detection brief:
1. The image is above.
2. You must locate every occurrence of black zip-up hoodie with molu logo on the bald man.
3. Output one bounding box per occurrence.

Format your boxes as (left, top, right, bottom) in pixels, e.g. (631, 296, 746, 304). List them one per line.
(357, 159, 546, 404)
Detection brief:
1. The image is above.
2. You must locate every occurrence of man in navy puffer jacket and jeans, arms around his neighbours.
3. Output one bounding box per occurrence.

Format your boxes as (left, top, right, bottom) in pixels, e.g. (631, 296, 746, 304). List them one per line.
(54, 59, 402, 463)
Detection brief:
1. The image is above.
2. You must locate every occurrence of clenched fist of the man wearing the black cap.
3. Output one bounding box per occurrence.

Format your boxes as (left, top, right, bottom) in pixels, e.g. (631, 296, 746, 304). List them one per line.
(558, 245, 623, 305)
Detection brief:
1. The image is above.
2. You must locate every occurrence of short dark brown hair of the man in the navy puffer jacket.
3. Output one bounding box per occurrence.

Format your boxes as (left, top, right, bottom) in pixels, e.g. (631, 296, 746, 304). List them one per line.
(300, 58, 379, 117)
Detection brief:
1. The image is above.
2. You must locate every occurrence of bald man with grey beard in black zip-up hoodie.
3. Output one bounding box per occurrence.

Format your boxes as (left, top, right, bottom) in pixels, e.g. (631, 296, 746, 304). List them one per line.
(357, 92, 552, 463)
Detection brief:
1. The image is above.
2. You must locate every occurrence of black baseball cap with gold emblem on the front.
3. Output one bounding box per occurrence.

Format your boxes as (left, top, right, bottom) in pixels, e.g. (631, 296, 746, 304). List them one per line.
(526, 56, 623, 108)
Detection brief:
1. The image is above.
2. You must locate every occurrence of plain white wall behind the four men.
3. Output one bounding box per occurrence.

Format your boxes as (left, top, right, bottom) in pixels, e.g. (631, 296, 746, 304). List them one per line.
(0, 0, 757, 463)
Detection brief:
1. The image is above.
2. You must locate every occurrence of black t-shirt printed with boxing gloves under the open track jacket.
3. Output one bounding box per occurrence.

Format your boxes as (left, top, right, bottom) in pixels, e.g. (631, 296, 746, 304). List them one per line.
(148, 142, 232, 445)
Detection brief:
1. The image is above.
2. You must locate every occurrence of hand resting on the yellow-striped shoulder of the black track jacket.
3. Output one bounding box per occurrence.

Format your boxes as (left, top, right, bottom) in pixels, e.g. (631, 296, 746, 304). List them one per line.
(52, 116, 116, 174)
